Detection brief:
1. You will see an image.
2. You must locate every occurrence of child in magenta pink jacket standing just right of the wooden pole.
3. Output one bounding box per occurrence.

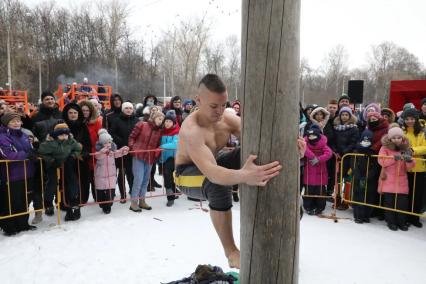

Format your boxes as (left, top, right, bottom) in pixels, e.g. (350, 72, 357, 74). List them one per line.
(303, 126, 333, 215)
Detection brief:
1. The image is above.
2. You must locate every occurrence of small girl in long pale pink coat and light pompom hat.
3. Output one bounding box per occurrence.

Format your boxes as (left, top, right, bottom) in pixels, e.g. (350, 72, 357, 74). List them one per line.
(95, 128, 129, 214)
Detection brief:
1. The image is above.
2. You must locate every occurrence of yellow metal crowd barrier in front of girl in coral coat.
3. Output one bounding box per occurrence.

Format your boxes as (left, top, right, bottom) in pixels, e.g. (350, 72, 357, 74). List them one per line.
(338, 153, 426, 218)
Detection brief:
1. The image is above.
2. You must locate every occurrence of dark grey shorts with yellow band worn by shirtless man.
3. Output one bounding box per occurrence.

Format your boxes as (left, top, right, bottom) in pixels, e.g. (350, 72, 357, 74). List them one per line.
(175, 147, 241, 211)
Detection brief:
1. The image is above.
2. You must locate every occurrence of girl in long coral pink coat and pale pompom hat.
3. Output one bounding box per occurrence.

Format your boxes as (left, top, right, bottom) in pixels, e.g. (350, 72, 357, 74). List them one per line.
(378, 125, 415, 231)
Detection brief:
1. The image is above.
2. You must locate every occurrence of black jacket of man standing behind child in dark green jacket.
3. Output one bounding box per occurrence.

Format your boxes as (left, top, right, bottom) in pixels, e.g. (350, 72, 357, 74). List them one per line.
(31, 104, 62, 142)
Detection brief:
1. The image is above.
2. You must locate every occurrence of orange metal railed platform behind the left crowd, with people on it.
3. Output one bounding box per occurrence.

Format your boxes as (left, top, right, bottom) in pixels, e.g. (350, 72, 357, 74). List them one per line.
(55, 84, 112, 110)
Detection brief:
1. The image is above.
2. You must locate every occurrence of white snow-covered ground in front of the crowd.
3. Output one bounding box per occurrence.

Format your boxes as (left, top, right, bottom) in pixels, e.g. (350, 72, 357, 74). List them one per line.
(0, 187, 426, 284)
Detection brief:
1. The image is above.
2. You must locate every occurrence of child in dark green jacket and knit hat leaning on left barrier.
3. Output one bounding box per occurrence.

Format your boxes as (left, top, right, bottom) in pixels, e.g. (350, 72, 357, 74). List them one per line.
(38, 123, 82, 221)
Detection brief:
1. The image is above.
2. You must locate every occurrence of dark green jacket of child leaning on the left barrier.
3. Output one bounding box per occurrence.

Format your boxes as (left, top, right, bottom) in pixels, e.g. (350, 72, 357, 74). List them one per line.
(38, 135, 82, 168)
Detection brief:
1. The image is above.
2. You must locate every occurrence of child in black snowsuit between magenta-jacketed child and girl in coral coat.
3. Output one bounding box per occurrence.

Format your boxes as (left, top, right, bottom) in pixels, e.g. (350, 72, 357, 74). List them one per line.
(351, 129, 379, 224)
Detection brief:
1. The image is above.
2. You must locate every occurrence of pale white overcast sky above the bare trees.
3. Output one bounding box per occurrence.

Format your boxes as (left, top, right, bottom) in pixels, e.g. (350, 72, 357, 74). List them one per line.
(24, 0, 426, 68)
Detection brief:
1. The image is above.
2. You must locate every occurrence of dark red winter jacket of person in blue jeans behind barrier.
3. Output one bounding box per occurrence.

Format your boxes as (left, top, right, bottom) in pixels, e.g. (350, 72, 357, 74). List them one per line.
(129, 121, 162, 164)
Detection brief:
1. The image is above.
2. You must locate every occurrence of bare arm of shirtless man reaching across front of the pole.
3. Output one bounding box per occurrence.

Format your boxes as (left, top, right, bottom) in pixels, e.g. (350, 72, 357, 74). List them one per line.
(180, 130, 282, 186)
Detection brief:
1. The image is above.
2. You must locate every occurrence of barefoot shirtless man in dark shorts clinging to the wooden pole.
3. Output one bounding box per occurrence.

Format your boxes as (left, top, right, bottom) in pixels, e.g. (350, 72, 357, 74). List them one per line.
(175, 74, 305, 268)
